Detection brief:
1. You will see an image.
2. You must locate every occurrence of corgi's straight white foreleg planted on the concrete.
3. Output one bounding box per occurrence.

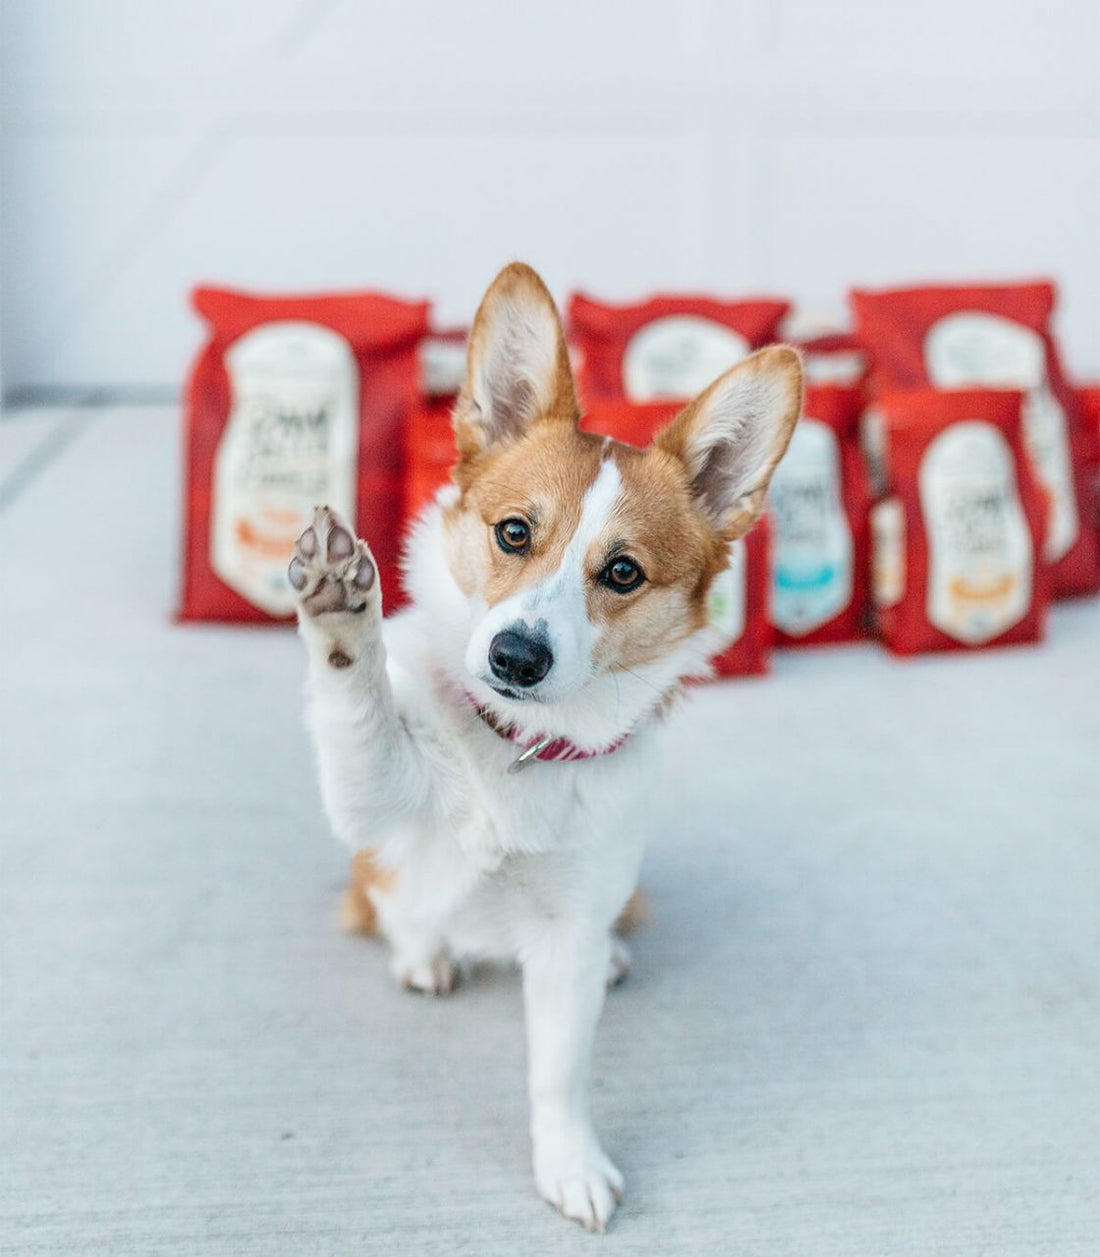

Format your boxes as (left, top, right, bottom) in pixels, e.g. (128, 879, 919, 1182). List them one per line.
(523, 928, 624, 1231)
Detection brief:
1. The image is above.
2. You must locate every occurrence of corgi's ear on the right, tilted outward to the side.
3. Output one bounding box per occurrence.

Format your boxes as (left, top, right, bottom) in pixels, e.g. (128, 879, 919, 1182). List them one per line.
(654, 344, 802, 541)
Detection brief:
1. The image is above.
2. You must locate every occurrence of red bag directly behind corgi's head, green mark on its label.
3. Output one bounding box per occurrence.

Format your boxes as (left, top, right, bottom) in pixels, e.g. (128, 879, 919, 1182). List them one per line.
(581, 401, 772, 676)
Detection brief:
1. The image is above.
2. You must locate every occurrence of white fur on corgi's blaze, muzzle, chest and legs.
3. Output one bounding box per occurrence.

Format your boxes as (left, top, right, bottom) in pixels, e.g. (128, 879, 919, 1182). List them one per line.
(287, 492, 729, 1229)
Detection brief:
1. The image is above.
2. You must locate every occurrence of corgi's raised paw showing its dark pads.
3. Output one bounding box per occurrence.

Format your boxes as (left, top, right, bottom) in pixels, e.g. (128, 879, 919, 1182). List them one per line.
(287, 507, 378, 617)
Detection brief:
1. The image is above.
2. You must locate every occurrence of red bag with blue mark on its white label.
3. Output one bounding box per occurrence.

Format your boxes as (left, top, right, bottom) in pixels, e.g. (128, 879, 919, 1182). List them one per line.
(768, 385, 870, 645)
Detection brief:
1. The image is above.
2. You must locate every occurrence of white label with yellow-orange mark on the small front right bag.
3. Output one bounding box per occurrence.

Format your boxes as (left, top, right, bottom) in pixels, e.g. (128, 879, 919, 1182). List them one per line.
(918, 420, 1035, 646)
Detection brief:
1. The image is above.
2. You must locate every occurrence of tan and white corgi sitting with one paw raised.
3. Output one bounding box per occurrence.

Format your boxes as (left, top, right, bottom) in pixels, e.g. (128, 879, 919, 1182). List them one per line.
(289, 263, 802, 1231)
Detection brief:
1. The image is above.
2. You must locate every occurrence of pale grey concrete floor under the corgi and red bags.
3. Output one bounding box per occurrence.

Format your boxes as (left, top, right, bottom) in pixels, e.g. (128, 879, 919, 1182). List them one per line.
(0, 409, 1100, 1257)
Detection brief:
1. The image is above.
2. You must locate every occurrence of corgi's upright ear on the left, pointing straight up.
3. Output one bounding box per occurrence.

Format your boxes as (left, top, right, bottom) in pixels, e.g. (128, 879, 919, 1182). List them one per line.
(454, 261, 578, 458)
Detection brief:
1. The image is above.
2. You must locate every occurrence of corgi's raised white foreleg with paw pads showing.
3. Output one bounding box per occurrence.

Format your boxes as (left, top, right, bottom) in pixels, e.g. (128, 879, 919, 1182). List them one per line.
(289, 507, 431, 851)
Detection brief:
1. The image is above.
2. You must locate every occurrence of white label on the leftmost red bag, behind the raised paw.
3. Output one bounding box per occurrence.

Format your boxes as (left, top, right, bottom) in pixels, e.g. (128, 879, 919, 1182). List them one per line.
(210, 321, 360, 616)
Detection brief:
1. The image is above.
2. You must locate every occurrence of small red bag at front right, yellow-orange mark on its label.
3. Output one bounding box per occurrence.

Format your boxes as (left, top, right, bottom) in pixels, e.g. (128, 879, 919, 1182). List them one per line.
(871, 390, 1048, 655)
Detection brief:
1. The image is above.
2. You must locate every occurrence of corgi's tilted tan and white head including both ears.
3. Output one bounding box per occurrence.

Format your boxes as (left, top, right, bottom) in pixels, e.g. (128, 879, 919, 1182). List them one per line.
(444, 264, 802, 729)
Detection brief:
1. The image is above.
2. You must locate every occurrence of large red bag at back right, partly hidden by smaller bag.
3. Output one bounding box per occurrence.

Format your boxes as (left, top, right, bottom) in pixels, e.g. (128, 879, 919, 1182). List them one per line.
(852, 283, 1100, 595)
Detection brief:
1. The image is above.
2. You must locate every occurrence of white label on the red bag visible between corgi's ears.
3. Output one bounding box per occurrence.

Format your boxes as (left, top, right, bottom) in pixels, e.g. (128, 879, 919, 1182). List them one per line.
(622, 314, 751, 401)
